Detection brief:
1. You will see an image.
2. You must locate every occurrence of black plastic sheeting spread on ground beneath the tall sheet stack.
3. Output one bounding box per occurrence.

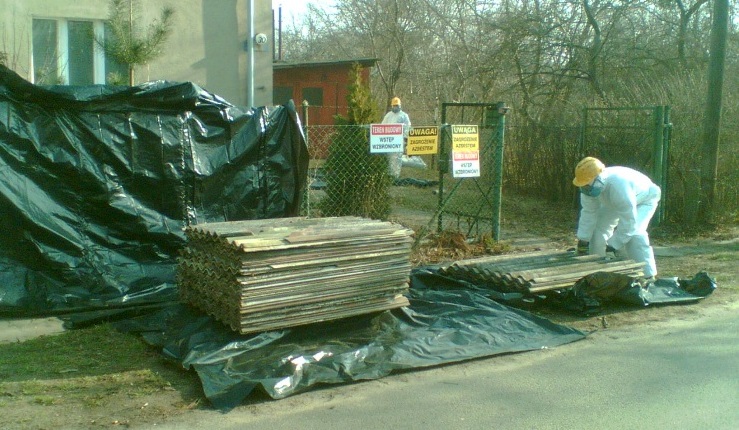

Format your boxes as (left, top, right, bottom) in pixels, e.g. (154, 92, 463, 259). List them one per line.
(117, 268, 585, 409)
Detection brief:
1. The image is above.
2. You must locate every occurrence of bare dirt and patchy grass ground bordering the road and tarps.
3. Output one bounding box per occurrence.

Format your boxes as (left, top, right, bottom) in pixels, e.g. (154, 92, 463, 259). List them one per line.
(0, 215, 739, 429)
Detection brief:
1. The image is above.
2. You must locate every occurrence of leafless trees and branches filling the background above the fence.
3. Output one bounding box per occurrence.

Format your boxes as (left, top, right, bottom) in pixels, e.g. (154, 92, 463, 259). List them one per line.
(282, 0, 739, 218)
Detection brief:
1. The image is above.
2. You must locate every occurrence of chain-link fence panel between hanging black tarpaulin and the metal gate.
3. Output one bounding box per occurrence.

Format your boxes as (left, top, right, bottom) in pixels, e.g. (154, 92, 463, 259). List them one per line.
(301, 125, 446, 227)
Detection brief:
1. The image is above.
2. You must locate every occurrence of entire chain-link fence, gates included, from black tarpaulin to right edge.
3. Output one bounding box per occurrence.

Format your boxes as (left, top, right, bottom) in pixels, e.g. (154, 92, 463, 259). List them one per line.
(302, 111, 739, 228)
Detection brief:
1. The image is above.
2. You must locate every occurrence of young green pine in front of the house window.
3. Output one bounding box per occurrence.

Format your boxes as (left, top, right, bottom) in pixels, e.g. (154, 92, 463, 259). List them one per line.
(95, 0, 174, 85)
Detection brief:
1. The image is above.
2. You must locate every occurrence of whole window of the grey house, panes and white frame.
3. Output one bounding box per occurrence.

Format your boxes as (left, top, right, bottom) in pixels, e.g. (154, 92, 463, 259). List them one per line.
(32, 19, 126, 85)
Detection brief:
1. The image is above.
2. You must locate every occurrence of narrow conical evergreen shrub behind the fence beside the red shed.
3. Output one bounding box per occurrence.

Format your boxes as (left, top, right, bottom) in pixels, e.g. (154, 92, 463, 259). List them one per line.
(319, 64, 391, 220)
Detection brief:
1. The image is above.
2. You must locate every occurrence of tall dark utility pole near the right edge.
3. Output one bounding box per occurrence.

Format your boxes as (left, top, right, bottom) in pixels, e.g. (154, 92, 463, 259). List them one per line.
(698, 0, 729, 223)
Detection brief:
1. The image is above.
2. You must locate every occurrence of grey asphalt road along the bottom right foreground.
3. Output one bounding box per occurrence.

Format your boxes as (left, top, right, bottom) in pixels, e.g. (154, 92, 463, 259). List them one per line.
(156, 306, 739, 430)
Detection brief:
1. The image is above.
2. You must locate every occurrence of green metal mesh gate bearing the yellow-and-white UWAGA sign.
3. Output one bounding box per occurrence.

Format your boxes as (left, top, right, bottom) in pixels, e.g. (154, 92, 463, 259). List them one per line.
(436, 102, 508, 240)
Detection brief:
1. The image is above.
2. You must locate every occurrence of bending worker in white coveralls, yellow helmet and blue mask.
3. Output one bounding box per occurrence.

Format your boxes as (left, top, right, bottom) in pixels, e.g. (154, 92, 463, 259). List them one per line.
(572, 157, 662, 279)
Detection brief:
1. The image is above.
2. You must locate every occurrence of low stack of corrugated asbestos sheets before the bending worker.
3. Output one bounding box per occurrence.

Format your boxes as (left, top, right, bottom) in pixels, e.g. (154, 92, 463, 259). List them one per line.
(440, 251, 644, 294)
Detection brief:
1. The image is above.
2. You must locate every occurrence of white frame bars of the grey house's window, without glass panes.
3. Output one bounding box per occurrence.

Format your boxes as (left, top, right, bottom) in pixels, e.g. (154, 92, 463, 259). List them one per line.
(31, 16, 105, 85)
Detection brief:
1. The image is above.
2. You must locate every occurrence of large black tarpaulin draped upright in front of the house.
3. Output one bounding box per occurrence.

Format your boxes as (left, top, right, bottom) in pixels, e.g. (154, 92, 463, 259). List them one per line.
(0, 66, 308, 315)
